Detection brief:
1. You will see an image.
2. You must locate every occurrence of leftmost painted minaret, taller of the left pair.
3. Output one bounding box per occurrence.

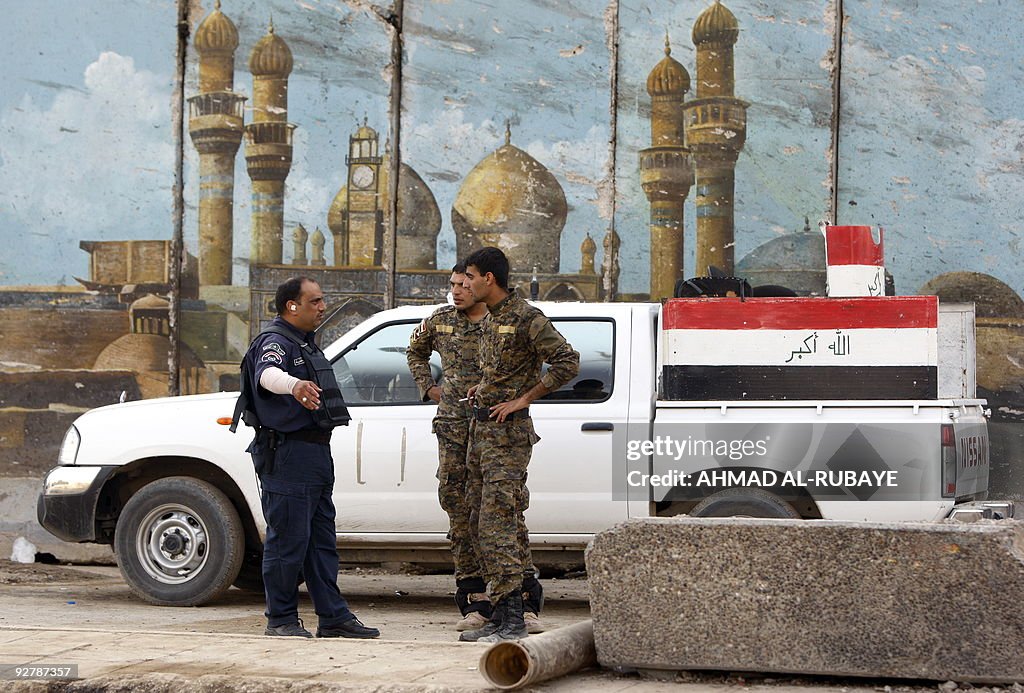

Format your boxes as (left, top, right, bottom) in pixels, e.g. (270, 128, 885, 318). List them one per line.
(188, 0, 246, 286)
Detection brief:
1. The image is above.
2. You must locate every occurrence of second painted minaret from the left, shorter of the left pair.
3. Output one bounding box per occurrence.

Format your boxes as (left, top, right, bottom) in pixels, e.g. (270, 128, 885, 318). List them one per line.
(246, 16, 295, 265)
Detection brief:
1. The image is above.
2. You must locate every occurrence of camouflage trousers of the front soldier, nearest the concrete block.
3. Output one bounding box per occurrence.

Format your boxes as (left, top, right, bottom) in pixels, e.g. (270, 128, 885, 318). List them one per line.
(466, 419, 540, 604)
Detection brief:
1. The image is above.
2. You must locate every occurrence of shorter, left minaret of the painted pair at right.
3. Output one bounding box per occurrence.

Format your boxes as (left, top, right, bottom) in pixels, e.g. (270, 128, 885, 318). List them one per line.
(640, 34, 693, 301)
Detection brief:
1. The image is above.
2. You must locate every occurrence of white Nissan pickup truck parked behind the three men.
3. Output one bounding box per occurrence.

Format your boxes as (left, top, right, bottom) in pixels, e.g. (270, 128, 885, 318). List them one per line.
(38, 299, 1012, 605)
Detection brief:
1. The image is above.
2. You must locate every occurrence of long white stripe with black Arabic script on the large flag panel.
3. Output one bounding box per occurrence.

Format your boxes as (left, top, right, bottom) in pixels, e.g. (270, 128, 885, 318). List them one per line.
(662, 328, 938, 365)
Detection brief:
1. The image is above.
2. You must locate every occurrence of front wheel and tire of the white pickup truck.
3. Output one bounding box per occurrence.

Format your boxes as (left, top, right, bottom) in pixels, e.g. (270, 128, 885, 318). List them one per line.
(114, 476, 245, 606)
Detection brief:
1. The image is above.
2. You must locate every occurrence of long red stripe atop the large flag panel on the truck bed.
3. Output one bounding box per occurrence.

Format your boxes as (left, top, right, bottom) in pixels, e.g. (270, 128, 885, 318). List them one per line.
(662, 296, 939, 330)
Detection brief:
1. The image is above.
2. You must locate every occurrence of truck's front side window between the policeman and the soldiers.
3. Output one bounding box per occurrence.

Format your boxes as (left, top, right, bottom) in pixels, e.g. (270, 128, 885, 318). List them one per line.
(334, 320, 441, 406)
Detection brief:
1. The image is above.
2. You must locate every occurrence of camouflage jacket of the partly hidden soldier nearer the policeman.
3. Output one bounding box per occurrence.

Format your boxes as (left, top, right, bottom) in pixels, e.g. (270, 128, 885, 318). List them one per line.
(406, 306, 483, 422)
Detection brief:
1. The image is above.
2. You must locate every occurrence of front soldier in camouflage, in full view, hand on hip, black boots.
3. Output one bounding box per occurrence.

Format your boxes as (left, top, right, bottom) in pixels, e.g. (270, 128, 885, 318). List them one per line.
(459, 248, 580, 642)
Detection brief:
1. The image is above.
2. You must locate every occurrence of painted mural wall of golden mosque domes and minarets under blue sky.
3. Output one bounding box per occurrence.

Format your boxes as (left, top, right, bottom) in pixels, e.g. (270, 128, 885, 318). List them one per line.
(0, 0, 1024, 497)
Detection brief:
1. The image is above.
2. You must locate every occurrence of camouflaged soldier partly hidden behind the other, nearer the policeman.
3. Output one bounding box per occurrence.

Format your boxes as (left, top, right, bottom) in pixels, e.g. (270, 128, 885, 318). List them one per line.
(406, 264, 490, 631)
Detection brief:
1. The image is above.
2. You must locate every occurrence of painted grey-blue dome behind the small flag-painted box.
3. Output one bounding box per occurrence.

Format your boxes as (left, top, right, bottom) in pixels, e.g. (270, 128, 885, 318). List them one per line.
(735, 231, 825, 296)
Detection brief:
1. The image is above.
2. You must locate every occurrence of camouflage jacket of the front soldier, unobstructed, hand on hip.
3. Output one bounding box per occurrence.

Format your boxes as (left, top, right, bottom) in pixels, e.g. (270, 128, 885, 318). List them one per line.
(476, 290, 580, 406)
